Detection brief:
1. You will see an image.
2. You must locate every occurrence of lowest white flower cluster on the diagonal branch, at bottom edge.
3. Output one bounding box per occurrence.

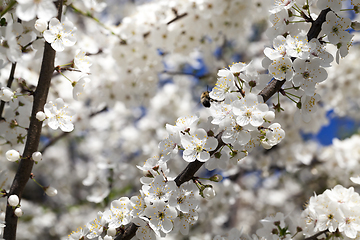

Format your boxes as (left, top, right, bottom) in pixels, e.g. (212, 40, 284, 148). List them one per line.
(69, 158, 199, 240)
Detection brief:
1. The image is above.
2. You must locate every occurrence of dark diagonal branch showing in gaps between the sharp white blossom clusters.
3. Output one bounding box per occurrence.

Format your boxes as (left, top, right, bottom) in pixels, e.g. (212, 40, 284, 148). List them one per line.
(115, 8, 330, 240)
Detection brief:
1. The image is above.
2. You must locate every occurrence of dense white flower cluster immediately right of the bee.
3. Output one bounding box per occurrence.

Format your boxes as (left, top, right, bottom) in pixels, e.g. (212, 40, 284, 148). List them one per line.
(202, 63, 285, 169)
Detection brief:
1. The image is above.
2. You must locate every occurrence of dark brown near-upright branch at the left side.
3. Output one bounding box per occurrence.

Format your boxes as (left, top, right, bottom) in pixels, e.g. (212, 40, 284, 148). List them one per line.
(4, 0, 63, 240)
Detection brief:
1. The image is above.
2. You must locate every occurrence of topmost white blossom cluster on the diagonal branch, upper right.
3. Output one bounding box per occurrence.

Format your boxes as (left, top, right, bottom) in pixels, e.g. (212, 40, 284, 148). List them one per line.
(262, 0, 354, 123)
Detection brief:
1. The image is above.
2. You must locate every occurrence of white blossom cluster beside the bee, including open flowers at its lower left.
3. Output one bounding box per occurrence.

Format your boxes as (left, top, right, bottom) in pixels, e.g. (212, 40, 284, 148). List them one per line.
(159, 63, 285, 170)
